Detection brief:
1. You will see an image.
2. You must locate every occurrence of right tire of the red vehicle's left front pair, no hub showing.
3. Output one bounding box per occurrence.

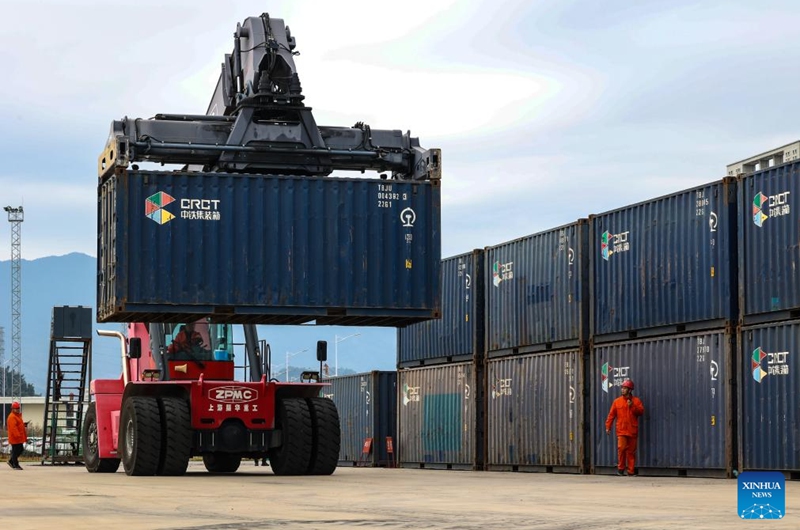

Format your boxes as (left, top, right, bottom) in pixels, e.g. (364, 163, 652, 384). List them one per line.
(158, 397, 192, 476)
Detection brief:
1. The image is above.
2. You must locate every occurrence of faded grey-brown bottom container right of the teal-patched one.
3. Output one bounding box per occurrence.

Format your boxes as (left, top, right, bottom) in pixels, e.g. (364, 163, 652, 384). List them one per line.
(486, 350, 584, 472)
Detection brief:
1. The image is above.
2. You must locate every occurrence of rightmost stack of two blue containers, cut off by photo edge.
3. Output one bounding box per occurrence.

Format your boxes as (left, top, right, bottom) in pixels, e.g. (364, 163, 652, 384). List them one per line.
(738, 162, 800, 473)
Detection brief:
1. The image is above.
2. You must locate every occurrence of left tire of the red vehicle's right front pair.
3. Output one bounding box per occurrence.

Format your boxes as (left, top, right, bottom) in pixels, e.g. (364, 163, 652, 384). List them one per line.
(269, 398, 313, 475)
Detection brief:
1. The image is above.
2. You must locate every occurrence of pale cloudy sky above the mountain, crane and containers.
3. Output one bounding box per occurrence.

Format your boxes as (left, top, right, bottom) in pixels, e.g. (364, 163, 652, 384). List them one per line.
(0, 0, 800, 259)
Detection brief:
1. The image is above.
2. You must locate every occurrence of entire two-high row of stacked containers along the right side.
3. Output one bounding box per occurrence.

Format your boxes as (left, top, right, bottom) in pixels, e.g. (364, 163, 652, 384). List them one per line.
(374, 163, 800, 475)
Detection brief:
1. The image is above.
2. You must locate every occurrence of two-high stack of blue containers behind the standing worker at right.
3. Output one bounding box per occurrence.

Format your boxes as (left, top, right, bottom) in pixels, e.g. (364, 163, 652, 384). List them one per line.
(589, 179, 736, 474)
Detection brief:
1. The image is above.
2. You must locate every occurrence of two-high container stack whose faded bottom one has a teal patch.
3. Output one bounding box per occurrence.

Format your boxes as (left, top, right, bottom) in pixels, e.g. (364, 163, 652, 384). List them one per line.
(397, 250, 485, 469)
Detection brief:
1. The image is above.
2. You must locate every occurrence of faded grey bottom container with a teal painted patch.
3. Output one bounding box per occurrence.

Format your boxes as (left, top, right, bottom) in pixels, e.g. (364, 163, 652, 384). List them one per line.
(397, 363, 482, 469)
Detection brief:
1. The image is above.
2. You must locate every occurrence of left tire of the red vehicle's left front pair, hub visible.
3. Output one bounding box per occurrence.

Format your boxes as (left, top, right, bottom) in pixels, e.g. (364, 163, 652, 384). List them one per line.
(119, 396, 161, 476)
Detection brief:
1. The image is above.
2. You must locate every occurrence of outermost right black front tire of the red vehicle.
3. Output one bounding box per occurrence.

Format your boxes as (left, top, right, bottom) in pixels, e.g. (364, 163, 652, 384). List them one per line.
(306, 398, 342, 475)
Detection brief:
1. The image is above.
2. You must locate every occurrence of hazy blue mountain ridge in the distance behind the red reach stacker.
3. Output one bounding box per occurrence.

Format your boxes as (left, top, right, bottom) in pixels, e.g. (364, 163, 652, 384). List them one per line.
(0, 253, 397, 394)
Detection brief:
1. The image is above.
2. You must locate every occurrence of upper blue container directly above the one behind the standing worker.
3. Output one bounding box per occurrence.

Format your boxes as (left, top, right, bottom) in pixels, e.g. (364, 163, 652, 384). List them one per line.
(591, 178, 737, 341)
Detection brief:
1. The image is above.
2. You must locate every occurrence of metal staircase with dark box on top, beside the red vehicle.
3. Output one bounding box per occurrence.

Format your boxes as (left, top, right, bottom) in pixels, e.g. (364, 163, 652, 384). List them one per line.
(42, 306, 92, 464)
